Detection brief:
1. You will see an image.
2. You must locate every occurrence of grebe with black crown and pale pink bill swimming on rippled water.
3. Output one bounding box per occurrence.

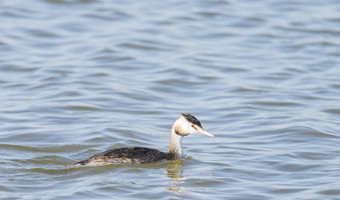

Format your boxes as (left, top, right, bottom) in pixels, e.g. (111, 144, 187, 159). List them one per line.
(73, 113, 214, 166)
